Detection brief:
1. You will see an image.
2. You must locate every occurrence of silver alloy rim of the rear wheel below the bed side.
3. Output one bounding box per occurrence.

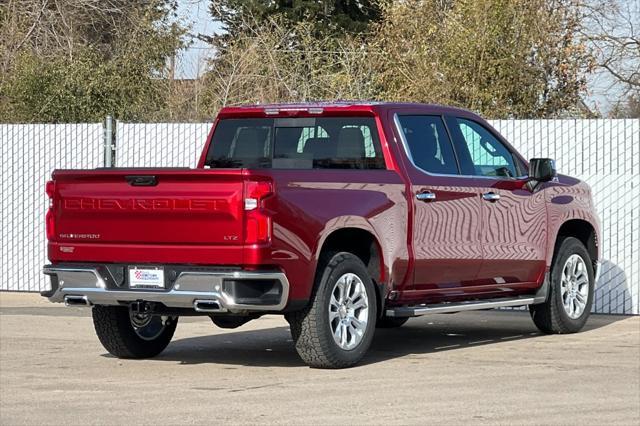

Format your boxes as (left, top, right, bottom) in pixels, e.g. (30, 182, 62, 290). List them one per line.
(329, 273, 369, 350)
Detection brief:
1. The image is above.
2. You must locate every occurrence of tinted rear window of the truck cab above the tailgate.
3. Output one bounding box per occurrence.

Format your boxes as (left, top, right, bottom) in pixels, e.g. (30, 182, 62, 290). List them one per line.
(205, 117, 385, 169)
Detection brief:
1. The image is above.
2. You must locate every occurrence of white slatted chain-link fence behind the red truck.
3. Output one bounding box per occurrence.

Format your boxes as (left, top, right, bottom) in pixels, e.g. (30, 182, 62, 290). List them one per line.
(0, 119, 640, 314)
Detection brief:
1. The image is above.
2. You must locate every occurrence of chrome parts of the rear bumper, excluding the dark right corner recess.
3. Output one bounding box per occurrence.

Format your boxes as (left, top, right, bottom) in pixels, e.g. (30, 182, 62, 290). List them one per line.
(43, 266, 289, 313)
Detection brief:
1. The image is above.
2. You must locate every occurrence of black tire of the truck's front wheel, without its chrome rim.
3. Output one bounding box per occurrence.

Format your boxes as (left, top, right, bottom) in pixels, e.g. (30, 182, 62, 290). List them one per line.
(529, 237, 595, 334)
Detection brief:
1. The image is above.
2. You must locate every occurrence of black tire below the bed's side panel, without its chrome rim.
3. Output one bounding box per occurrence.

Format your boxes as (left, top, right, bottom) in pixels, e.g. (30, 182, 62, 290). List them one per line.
(287, 252, 377, 368)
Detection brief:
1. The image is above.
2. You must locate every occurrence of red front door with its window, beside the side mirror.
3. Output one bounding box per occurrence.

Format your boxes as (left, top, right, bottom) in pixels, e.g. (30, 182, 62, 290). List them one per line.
(447, 117, 547, 292)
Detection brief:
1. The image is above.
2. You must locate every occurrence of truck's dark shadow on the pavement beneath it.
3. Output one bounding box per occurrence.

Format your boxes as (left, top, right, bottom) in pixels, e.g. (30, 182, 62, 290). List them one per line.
(146, 311, 627, 369)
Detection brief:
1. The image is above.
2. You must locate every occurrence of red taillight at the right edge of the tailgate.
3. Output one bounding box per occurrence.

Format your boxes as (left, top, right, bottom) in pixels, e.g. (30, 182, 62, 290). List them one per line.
(244, 181, 273, 244)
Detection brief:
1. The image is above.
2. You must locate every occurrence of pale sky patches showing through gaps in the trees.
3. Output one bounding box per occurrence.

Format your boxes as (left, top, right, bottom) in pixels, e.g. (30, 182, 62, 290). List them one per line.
(176, 0, 640, 114)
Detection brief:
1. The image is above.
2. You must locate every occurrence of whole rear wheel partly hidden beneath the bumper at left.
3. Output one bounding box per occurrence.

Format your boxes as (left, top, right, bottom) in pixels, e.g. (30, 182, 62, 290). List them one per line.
(92, 305, 178, 358)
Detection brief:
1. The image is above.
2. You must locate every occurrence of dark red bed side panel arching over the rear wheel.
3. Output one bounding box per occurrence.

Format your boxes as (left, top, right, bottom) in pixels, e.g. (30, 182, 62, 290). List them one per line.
(244, 169, 408, 300)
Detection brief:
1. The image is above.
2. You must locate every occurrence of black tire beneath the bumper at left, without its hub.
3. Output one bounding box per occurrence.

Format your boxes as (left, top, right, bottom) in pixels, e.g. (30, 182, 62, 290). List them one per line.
(92, 305, 178, 359)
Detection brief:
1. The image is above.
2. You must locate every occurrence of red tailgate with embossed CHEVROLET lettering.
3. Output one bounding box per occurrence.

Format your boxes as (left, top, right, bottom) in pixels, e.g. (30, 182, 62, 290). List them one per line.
(51, 169, 243, 246)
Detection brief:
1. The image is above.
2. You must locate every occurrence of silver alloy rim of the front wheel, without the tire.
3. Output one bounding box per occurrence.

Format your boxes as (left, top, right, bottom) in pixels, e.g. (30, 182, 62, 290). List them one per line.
(560, 254, 589, 319)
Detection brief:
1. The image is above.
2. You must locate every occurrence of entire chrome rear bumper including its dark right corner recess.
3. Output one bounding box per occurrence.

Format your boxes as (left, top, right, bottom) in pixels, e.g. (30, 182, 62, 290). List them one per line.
(43, 265, 289, 313)
